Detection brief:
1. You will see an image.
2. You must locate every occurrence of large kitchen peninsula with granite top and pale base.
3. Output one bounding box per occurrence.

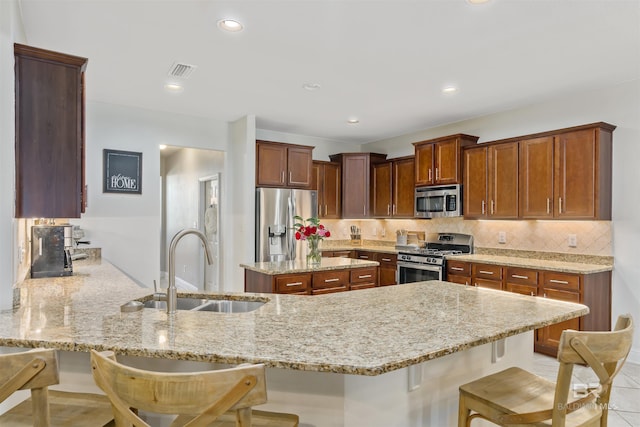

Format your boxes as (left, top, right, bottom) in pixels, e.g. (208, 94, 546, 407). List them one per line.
(0, 261, 588, 427)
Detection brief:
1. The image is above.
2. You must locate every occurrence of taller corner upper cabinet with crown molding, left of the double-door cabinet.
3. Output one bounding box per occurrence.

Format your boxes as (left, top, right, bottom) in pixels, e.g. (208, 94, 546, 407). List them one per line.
(329, 153, 387, 218)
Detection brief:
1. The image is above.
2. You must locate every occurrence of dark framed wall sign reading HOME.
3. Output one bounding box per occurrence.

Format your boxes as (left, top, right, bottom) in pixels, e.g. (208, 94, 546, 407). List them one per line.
(102, 148, 142, 194)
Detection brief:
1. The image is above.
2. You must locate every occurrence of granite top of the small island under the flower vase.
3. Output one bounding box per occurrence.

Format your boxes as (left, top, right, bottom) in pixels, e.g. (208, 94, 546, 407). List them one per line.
(240, 257, 380, 276)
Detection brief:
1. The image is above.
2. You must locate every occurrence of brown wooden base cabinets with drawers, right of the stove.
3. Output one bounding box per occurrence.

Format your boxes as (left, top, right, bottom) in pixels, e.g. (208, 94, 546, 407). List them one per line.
(447, 260, 611, 357)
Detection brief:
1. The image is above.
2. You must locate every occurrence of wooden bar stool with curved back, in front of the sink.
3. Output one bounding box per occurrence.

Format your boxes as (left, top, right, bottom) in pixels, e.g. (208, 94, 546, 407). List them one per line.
(91, 350, 298, 427)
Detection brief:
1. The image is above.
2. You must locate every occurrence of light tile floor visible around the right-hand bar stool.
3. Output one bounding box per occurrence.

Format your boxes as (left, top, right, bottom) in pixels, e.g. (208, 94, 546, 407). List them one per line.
(534, 353, 640, 427)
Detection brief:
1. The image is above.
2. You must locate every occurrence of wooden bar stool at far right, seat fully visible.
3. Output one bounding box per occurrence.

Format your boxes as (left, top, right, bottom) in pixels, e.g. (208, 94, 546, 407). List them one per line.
(458, 314, 633, 427)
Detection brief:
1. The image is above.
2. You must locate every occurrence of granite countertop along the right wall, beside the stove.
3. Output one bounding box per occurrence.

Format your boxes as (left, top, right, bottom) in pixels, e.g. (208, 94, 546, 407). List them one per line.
(446, 254, 613, 274)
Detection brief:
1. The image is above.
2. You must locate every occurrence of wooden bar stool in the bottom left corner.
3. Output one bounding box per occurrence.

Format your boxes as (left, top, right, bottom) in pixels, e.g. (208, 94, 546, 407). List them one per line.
(0, 349, 113, 427)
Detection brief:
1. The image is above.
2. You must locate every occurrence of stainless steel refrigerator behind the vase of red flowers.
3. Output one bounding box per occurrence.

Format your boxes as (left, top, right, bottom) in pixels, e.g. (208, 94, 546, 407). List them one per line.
(256, 188, 318, 262)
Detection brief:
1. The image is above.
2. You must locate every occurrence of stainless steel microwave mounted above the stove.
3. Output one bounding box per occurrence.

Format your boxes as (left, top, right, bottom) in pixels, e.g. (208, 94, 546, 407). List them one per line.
(415, 184, 462, 218)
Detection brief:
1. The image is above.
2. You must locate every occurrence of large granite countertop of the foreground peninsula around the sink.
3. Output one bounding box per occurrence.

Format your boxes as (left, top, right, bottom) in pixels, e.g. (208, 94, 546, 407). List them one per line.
(0, 261, 588, 375)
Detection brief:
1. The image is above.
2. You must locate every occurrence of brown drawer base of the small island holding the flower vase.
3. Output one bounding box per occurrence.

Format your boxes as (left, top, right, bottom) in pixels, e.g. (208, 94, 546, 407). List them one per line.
(244, 267, 378, 295)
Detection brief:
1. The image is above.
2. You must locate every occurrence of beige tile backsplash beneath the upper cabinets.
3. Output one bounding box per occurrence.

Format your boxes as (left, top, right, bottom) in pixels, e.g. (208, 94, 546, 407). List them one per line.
(322, 218, 612, 256)
